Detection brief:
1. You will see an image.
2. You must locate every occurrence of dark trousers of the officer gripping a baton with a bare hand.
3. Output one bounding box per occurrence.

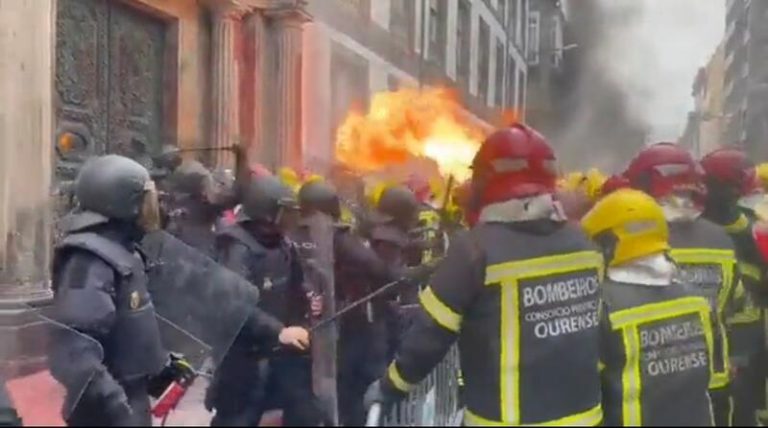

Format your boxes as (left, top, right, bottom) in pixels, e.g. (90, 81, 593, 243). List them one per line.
(211, 355, 325, 426)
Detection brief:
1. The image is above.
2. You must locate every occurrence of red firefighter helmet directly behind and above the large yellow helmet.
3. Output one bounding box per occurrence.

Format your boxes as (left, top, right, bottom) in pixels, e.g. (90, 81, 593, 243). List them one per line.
(623, 143, 705, 199)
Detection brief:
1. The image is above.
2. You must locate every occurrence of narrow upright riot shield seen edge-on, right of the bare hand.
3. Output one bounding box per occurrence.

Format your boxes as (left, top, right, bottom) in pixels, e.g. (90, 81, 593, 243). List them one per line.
(295, 213, 338, 425)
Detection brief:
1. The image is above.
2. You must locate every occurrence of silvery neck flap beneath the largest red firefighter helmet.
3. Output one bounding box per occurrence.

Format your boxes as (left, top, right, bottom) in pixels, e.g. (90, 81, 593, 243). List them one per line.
(479, 194, 566, 223)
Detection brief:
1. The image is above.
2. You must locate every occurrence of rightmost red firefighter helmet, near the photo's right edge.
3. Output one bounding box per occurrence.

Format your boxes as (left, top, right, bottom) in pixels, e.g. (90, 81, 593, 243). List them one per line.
(701, 148, 761, 196)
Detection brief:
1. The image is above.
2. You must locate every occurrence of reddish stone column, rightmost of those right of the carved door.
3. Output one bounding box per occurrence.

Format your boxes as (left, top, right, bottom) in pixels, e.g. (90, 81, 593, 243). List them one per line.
(269, 8, 308, 168)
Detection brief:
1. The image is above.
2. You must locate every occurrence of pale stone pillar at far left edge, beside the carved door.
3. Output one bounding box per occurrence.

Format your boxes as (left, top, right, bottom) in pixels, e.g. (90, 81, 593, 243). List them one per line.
(0, 0, 56, 308)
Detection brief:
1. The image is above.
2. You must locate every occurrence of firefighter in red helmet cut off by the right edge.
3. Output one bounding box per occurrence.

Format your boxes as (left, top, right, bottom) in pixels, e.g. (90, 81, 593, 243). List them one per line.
(701, 149, 768, 426)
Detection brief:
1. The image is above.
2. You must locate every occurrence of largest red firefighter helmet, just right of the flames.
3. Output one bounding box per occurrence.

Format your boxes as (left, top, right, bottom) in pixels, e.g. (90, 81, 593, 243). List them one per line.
(472, 124, 557, 211)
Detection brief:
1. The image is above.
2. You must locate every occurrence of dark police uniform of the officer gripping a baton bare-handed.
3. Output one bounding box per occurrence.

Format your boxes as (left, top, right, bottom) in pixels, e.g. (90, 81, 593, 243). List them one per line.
(211, 223, 322, 426)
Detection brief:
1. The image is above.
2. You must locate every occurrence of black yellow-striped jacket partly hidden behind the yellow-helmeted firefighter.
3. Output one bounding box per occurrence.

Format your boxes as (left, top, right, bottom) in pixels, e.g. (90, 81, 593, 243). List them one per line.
(669, 218, 738, 388)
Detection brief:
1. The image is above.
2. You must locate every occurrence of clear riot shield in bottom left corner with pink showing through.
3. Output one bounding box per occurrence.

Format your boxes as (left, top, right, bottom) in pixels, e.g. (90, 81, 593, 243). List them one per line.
(0, 307, 103, 426)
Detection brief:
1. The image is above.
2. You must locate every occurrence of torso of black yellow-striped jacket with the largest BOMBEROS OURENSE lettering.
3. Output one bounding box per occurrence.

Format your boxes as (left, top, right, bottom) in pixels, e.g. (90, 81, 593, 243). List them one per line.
(459, 224, 603, 426)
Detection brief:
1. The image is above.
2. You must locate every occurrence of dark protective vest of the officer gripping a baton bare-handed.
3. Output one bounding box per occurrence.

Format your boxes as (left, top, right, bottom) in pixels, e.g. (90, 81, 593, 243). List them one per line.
(219, 224, 297, 323)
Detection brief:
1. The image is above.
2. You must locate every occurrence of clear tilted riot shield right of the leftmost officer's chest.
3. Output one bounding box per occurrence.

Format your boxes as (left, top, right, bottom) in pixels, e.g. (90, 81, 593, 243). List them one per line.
(142, 231, 259, 367)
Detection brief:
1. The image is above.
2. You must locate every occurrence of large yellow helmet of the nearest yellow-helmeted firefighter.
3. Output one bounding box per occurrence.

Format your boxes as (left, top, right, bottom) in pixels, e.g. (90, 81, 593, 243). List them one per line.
(581, 189, 669, 266)
